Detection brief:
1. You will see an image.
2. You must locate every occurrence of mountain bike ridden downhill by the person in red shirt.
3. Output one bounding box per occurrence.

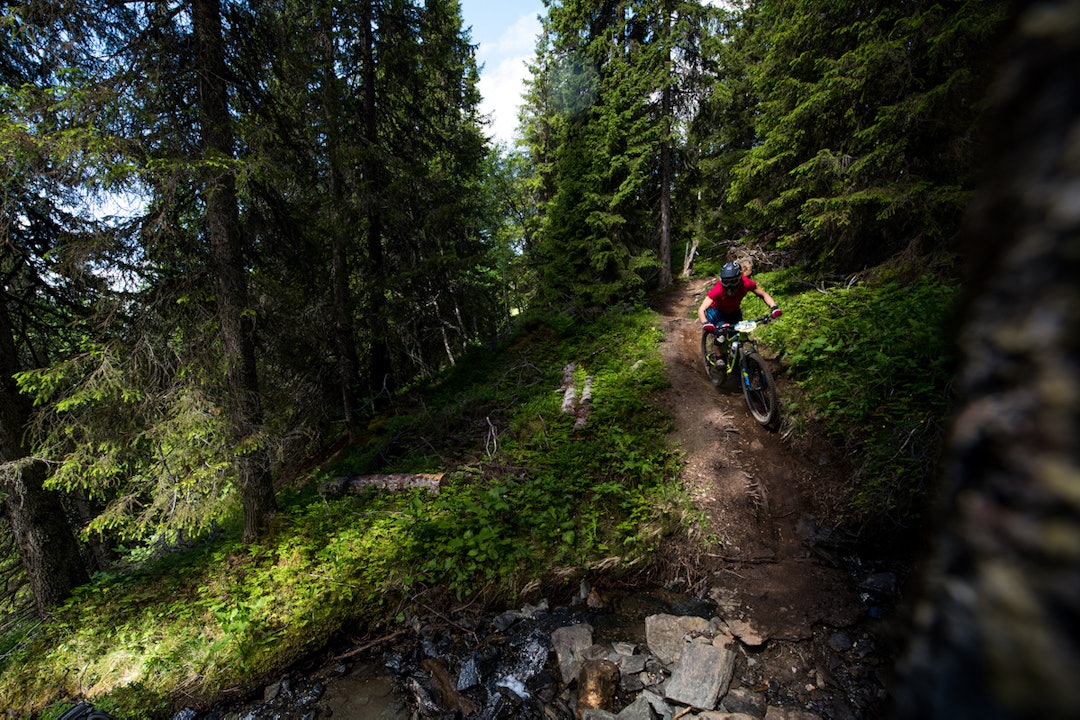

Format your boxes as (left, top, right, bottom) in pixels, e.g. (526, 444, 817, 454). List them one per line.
(701, 315, 780, 427)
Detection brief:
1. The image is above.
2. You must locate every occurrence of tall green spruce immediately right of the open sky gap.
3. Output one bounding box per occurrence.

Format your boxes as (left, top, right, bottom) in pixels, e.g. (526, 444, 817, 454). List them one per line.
(526, 0, 665, 311)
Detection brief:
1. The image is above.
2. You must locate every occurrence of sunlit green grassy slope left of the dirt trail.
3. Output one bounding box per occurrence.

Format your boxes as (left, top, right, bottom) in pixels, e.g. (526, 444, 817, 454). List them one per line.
(0, 311, 684, 719)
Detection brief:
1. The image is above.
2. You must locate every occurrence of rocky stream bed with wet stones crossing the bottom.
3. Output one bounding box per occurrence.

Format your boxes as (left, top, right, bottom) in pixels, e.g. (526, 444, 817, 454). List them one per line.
(183, 584, 882, 720)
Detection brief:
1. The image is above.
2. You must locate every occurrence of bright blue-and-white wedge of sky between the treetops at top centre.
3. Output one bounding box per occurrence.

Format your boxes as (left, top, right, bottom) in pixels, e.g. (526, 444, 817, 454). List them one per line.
(461, 0, 544, 147)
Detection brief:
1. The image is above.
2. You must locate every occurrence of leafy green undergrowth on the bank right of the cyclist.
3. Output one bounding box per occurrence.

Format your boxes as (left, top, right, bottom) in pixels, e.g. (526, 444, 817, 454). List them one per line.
(760, 268, 958, 531)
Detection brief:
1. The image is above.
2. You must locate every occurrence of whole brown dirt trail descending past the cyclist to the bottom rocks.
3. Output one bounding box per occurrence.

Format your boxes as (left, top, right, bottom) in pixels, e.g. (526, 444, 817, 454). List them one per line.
(653, 280, 880, 717)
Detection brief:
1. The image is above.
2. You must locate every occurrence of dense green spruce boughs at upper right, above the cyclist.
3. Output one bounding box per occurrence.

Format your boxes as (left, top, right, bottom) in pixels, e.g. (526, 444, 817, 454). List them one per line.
(728, 0, 1005, 271)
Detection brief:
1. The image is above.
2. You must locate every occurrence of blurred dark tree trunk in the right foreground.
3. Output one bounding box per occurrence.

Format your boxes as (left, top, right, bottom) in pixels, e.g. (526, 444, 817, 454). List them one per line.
(897, 0, 1080, 720)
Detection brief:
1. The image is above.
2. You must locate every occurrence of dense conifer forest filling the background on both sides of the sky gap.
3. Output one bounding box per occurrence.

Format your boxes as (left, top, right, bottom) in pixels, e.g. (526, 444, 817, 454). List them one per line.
(0, 0, 1009, 612)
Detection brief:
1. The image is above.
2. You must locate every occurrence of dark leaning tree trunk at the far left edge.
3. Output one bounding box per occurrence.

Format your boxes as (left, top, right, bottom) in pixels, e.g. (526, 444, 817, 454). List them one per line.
(0, 301, 90, 615)
